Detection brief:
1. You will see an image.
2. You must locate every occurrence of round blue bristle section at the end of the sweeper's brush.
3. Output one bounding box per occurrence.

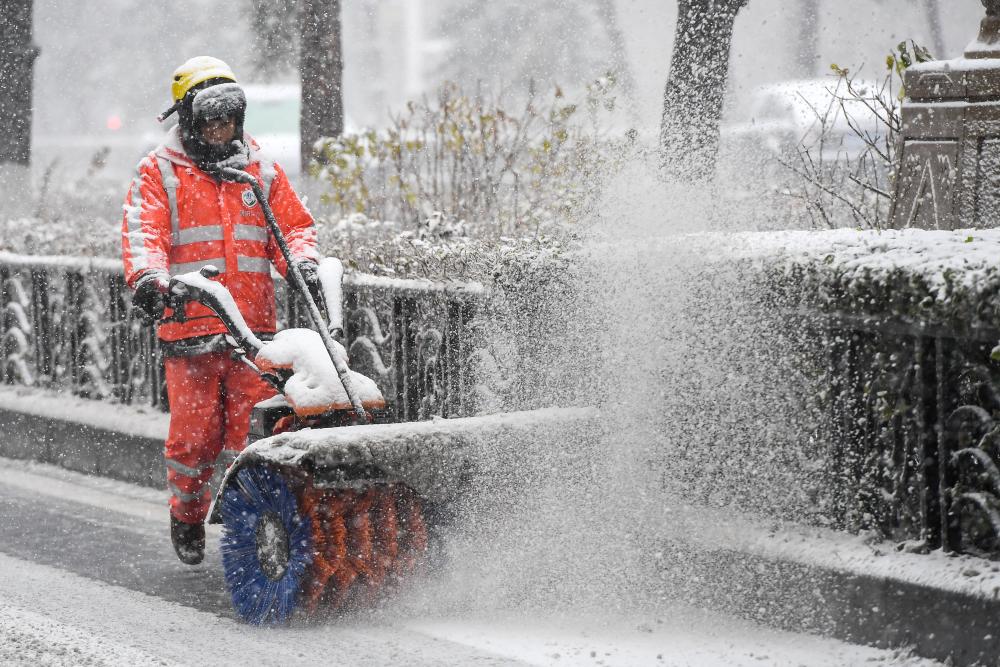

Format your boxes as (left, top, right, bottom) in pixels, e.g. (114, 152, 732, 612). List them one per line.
(222, 466, 312, 625)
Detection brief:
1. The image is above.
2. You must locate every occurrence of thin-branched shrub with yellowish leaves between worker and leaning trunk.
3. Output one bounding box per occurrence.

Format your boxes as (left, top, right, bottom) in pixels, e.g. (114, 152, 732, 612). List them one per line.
(312, 76, 634, 238)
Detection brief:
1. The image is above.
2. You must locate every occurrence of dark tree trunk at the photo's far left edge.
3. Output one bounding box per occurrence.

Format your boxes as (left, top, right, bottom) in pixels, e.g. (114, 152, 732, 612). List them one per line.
(0, 0, 38, 166)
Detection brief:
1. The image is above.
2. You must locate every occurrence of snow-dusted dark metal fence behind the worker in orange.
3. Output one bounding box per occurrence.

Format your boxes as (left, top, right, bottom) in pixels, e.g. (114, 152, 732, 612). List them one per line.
(0, 253, 483, 421)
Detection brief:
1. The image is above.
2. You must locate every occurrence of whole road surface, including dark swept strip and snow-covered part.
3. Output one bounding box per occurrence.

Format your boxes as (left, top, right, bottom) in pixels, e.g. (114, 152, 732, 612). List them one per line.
(0, 459, 938, 666)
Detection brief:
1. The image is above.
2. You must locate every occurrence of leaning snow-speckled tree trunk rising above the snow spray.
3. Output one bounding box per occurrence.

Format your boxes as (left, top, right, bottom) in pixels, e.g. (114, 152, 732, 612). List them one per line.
(660, 0, 747, 180)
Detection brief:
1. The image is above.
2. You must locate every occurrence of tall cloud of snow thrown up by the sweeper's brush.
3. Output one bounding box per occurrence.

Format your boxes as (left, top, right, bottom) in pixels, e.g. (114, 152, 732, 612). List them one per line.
(378, 151, 815, 611)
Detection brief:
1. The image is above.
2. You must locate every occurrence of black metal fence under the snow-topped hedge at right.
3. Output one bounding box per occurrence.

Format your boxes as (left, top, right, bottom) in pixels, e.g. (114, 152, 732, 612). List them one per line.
(820, 314, 1000, 558)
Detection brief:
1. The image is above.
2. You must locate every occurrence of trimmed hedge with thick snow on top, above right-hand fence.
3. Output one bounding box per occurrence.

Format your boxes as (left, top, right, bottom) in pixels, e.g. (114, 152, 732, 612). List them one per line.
(733, 229, 1000, 334)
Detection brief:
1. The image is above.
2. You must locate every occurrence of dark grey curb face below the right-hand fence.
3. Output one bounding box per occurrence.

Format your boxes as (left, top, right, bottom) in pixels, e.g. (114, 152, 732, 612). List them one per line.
(659, 545, 1000, 667)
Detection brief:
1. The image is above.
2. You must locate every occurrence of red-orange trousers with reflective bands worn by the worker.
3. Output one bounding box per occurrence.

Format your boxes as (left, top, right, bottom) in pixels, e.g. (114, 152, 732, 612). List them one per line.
(164, 351, 275, 523)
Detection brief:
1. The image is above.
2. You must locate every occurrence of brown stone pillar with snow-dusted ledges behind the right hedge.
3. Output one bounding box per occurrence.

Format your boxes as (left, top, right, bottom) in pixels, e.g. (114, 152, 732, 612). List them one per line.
(890, 0, 1000, 229)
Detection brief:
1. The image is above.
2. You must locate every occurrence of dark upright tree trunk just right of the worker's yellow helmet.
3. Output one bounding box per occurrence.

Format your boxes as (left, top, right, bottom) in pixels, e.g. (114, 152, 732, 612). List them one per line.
(299, 0, 344, 174)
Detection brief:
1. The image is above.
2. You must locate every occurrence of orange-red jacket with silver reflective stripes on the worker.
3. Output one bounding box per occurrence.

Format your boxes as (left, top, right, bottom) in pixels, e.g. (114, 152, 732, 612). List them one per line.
(122, 127, 318, 341)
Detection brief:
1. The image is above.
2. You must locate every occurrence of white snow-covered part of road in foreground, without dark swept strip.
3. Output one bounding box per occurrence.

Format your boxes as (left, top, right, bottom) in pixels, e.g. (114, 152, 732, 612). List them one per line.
(0, 555, 939, 666)
